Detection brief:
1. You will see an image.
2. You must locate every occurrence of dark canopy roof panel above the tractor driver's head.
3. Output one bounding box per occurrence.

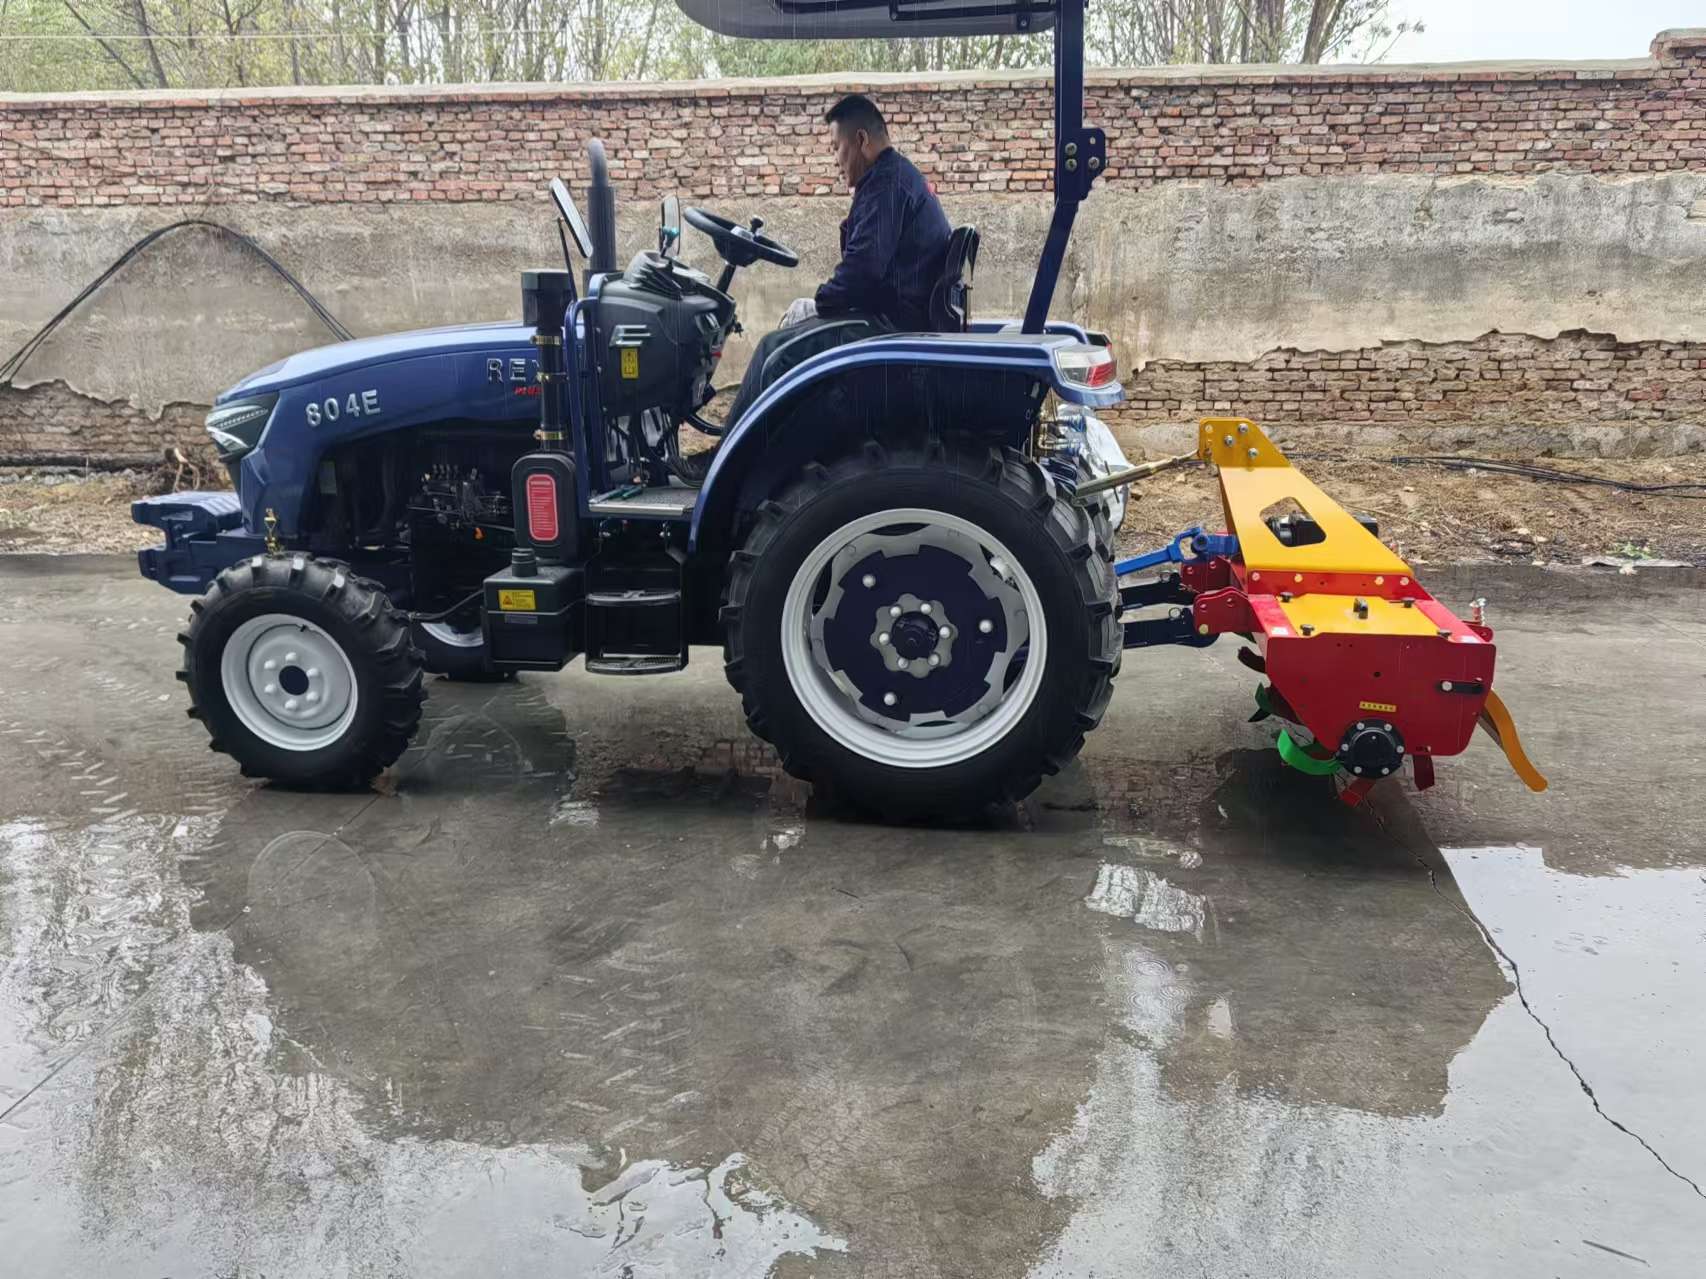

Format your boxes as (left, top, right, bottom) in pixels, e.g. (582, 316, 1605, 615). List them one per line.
(676, 0, 1054, 39)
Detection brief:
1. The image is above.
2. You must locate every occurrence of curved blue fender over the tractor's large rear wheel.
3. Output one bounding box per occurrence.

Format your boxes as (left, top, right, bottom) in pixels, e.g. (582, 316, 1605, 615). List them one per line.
(689, 333, 1123, 551)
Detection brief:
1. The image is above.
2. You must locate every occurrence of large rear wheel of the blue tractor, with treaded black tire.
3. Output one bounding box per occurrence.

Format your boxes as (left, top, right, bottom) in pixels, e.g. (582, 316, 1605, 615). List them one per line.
(723, 443, 1121, 820)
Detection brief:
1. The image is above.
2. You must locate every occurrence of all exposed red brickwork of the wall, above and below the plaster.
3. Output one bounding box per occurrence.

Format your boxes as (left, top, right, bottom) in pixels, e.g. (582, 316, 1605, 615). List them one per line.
(0, 31, 1706, 459)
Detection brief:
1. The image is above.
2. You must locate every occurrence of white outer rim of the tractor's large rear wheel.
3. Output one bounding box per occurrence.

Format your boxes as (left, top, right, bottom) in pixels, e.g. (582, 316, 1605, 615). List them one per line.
(781, 506, 1047, 769)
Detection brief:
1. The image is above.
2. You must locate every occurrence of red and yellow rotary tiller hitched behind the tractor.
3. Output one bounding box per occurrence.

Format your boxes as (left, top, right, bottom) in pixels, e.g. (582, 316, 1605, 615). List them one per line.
(1112, 418, 1546, 805)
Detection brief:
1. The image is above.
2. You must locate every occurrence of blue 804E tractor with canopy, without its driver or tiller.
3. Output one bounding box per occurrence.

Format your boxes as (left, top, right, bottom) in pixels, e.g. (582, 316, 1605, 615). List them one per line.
(135, 0, 1146, 817)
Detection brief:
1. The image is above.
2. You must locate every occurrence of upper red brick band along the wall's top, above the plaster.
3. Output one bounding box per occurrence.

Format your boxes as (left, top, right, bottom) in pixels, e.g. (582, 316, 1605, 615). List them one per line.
(0, 31, 1706, 206)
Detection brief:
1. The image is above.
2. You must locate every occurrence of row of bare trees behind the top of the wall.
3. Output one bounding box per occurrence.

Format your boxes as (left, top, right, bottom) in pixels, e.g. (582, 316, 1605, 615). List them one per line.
(0, 0, 1419, 89)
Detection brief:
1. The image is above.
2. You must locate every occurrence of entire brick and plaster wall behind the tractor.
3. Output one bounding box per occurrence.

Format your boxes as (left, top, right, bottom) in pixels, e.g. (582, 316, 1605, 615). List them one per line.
(0, 31, 1706, 457)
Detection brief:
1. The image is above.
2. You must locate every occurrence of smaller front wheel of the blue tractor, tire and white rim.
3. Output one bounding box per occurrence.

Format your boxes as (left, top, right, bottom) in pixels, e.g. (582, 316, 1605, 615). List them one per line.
(177, 554, 425, 786)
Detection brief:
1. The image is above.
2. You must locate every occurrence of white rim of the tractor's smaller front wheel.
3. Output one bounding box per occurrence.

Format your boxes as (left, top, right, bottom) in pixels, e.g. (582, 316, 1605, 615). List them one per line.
(218, 612, 358, 750)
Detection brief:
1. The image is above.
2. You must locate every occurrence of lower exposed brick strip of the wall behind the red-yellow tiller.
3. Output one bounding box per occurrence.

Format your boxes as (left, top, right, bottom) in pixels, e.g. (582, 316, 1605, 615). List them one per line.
(1121, 329, 1706, 423)
